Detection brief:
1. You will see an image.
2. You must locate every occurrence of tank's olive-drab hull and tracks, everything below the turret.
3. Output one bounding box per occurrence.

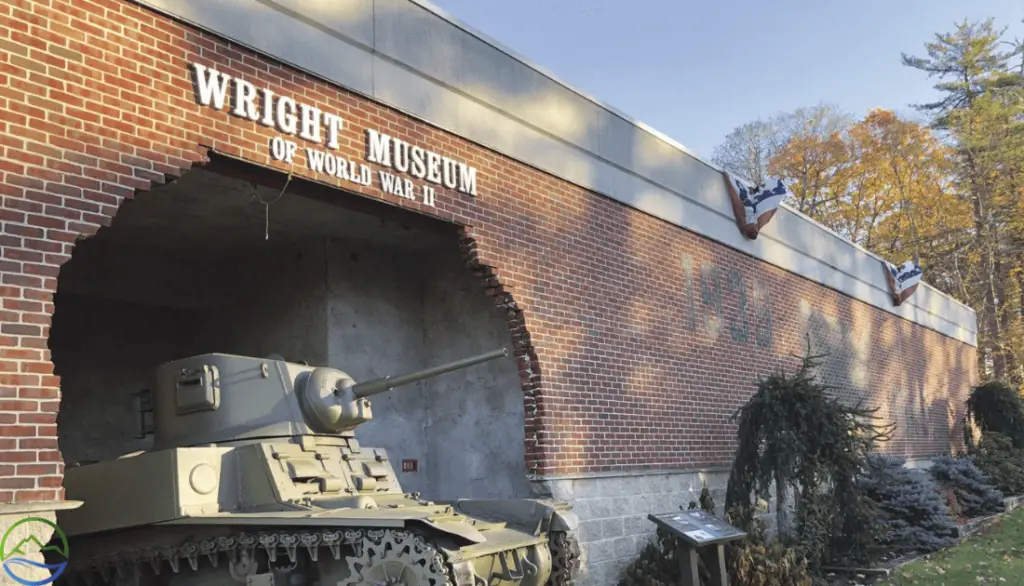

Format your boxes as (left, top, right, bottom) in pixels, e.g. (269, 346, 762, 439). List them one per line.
(57, 437, 579, 586)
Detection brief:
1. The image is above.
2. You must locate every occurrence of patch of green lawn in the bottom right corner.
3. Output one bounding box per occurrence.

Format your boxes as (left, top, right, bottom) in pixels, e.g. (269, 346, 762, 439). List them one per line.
(878, 507, 1024, 586)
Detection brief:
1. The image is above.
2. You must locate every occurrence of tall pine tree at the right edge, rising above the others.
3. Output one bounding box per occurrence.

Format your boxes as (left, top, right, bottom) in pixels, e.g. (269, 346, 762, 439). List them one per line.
(903, 19, 1024, 382)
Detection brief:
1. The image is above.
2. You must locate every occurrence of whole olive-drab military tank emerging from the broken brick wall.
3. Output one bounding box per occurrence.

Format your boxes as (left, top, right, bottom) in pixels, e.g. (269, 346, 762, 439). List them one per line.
(57, 349, 580, 586)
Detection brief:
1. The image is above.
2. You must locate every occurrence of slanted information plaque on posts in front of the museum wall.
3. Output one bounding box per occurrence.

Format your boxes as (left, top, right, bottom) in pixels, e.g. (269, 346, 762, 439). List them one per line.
(647, 509, 746, 586)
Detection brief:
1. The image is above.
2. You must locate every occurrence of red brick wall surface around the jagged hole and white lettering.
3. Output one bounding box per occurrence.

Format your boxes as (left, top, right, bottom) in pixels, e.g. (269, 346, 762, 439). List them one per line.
(0, 0, 975, 502)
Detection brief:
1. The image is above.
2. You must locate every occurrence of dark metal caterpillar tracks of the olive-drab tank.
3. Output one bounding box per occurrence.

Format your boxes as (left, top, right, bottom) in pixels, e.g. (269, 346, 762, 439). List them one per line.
(60, 529, 580, 586)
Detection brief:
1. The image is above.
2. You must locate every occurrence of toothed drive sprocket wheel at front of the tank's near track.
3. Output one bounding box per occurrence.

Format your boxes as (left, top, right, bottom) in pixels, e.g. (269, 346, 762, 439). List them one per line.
(339, 529, 453, 586)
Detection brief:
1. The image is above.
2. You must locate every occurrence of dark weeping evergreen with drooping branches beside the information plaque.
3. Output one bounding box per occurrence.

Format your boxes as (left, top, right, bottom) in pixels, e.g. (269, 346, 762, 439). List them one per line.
(726, 341, 891, 569)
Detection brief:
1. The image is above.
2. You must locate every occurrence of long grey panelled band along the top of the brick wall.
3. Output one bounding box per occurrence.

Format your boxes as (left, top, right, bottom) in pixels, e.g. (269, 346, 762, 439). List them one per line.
(119, 0, 977, 346)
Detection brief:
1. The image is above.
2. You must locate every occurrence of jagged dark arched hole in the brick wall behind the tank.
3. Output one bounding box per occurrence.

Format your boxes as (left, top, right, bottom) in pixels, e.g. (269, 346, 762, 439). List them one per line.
(50, 162, 528, 499)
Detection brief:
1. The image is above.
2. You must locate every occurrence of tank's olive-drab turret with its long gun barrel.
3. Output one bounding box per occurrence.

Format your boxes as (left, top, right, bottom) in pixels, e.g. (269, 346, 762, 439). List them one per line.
(139, 348, 508, 450)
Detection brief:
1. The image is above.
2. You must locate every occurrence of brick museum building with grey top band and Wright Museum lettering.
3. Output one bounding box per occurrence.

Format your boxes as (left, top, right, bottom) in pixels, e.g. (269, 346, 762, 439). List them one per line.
(0, 0, 978, 584)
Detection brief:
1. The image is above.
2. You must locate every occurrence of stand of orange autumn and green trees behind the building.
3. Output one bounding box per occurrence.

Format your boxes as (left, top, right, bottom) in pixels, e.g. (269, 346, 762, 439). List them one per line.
(714, 16, 1024, 385)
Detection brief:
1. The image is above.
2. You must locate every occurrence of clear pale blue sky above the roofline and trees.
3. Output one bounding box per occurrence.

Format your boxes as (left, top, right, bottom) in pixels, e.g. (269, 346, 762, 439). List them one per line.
(432, 0, 1024, 158)
